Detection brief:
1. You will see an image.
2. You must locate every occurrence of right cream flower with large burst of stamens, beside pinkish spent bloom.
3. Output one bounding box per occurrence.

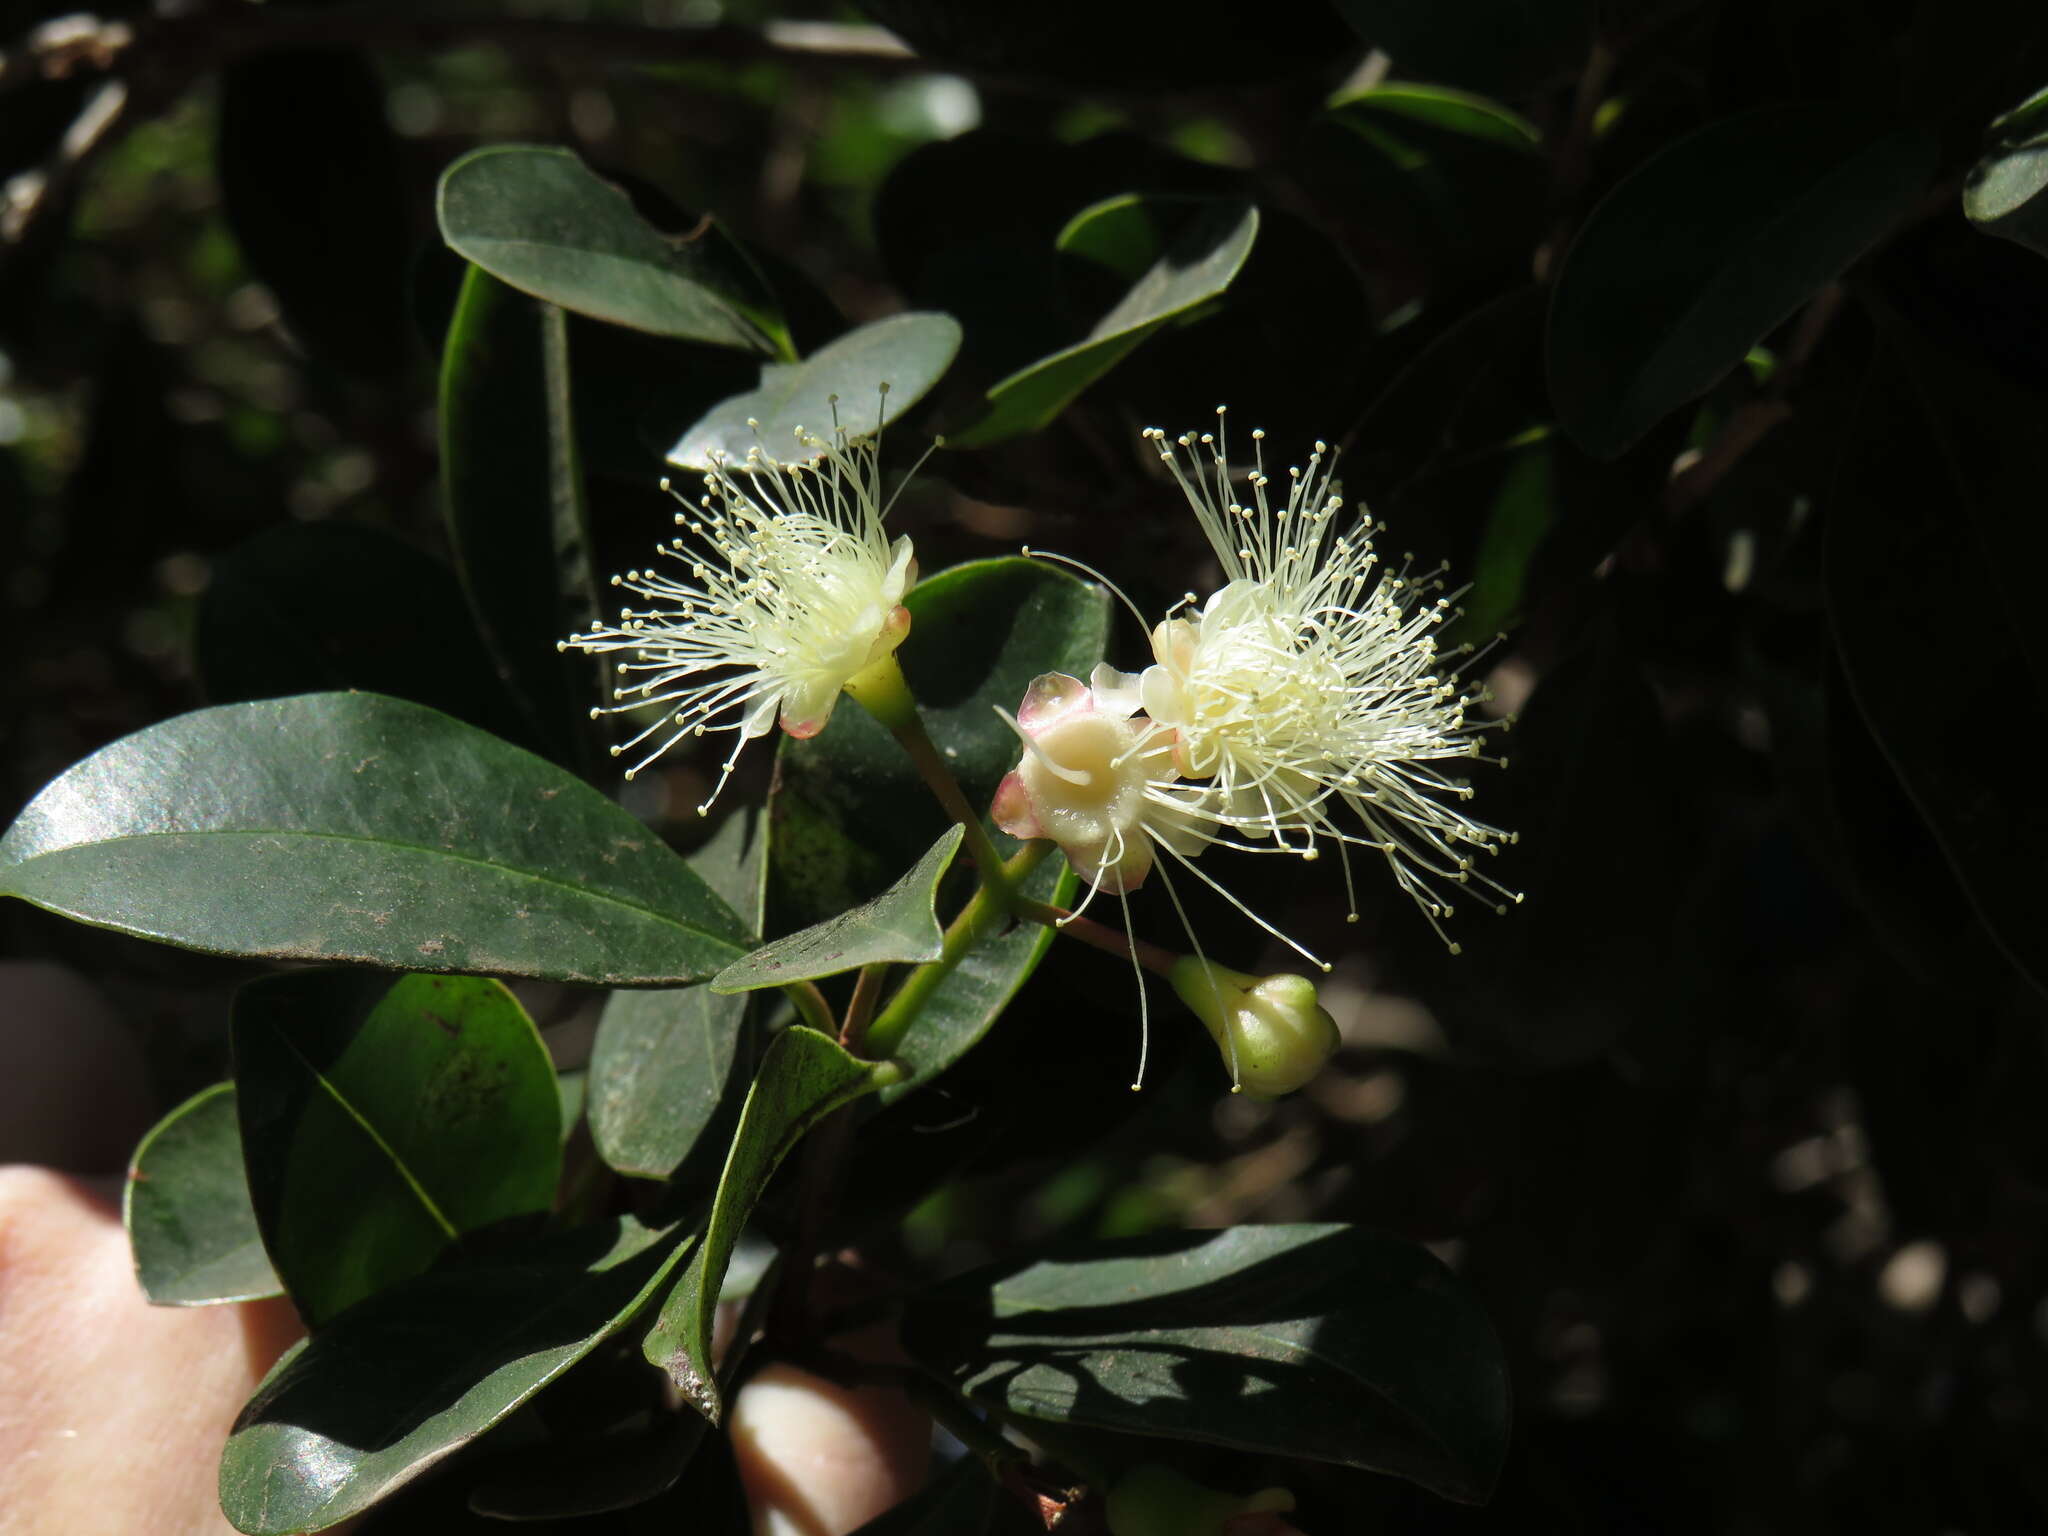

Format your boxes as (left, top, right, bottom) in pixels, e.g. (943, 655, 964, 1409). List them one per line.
(1139, 412, 1520, 950)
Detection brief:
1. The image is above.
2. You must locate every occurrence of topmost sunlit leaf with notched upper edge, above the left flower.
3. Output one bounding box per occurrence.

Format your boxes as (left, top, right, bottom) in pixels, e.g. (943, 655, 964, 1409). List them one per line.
(436, 143, 795, 356)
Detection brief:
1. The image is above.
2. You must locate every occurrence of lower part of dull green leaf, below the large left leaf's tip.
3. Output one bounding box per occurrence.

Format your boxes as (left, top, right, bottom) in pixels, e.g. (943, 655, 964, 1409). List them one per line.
(590, 987, 748, 1180)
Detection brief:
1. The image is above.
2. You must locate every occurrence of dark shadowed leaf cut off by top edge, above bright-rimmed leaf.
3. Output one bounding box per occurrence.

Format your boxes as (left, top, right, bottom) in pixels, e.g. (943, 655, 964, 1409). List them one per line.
(1337, 0, 1593, 92)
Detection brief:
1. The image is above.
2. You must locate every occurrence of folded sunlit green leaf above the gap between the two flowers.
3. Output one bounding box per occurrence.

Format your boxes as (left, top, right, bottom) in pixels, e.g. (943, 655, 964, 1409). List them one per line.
(946, 195, 1260, 449)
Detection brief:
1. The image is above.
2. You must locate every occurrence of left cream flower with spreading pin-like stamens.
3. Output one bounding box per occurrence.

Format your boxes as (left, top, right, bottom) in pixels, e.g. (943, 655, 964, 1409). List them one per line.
(559, 415, 918, 811)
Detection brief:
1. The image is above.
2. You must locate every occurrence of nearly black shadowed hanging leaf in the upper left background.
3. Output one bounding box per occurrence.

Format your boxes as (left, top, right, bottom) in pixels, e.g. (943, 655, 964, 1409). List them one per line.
(217, 47, 412, 375)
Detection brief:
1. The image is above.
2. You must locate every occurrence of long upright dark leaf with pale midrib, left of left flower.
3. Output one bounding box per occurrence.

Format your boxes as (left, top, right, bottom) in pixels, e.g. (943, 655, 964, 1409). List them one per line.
(440, 268, 598, 762)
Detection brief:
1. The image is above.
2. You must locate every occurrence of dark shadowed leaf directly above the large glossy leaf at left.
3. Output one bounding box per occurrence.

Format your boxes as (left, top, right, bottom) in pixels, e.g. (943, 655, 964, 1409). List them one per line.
(193, 522, 526, 745)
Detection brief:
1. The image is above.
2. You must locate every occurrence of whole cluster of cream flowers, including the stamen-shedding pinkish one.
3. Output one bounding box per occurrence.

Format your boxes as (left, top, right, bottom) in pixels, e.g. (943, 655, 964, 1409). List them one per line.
(565, 410, 1520, 1089)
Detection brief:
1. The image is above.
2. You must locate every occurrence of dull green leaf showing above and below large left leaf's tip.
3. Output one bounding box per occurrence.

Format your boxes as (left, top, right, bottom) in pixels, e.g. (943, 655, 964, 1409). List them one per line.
(590, 811, 768, 1178)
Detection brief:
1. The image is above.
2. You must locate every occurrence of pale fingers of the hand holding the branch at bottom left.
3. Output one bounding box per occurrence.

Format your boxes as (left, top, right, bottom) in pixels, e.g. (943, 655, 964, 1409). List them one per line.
(0, 963, 930, 1536)
